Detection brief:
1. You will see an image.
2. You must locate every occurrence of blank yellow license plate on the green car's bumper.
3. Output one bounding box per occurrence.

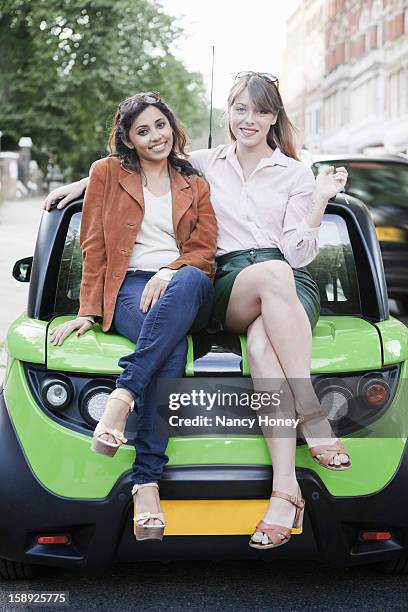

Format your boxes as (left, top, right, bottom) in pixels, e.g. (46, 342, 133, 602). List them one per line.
(134, 499, 302, 536)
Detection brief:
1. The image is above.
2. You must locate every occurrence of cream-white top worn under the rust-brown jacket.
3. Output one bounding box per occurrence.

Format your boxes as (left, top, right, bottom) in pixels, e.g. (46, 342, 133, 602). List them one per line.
(128, 187, 180, 280)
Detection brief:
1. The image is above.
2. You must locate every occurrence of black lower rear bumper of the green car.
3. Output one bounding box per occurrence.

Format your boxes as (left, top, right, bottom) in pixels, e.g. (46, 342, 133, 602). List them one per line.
(0, 394, 408, 568)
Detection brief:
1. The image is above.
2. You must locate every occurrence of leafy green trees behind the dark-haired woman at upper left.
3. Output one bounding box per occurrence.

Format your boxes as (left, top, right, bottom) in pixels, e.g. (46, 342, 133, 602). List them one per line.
(0, 0, 207, 179)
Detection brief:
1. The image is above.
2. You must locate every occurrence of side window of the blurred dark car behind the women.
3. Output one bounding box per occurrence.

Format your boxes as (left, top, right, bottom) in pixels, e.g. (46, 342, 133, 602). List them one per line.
(312, 160, 408, 207)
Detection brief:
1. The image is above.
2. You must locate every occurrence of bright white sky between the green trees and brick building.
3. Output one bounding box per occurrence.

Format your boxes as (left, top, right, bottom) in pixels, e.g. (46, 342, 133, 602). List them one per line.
(159, 0, 301, 108)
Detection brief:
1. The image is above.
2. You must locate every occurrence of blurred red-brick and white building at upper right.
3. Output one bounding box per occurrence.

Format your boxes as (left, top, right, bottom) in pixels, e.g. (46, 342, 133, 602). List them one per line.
(282, 0, 408, 152)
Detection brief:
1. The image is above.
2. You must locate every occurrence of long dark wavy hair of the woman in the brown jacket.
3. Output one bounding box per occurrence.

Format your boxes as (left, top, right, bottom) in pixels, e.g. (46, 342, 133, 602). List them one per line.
(108, 92, 199, 176)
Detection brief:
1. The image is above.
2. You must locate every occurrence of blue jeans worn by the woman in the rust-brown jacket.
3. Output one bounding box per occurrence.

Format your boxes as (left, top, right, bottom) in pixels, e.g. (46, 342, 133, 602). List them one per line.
(113, 266, 214, 484)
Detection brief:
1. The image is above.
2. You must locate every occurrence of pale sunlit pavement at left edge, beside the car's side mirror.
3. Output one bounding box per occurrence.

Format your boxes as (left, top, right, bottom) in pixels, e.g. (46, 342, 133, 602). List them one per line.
(0, 198, 43, 382)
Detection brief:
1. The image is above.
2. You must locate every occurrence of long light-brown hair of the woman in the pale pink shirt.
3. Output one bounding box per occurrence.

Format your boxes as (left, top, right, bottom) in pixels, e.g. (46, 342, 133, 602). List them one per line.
(228, 73, 299, 159)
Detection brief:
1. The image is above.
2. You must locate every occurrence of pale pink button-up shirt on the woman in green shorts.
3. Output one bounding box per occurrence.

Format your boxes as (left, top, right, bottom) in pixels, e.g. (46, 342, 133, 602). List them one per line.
(189, 143, 320, 268)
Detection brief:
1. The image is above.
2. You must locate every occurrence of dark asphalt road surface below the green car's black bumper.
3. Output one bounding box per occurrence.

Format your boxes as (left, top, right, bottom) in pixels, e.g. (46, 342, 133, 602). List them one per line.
(0, 556, 408, 612)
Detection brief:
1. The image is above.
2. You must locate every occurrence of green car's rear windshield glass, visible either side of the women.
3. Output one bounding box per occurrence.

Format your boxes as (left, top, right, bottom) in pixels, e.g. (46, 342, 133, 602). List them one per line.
(55, 213, 361, 315)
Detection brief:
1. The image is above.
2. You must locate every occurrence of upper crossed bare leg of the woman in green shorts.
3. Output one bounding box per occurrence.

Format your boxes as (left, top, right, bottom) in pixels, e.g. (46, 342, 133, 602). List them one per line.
(226, 261, 349, 465)
